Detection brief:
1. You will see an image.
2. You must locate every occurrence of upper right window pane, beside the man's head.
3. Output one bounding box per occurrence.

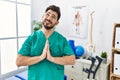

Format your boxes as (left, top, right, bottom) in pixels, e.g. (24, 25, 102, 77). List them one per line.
(17, 4, 31, 37)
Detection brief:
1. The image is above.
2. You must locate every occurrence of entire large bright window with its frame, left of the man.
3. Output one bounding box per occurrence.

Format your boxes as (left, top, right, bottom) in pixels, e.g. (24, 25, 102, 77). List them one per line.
(0, 0, 31, 79)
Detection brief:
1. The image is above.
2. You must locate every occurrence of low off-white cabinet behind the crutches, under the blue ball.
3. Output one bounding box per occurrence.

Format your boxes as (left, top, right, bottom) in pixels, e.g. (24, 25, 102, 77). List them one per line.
(65, 59, 109, 80)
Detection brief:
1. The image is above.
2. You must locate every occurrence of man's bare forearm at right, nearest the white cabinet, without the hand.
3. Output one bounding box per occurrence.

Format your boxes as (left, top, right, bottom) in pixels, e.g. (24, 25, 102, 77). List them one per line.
(51, 55, 75, 65)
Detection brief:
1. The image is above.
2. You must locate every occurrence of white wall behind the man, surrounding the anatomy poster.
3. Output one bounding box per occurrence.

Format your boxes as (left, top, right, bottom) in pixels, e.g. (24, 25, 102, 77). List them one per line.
(32, 0, 120, 58)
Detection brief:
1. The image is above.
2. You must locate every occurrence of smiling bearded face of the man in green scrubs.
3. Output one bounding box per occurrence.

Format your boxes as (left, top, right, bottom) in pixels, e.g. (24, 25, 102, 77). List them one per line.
(42, 10, 58, 30)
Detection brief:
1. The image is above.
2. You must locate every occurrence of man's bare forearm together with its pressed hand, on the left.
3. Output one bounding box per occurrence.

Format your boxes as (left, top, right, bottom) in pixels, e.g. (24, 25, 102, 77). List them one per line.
(16, 41, 48, 67)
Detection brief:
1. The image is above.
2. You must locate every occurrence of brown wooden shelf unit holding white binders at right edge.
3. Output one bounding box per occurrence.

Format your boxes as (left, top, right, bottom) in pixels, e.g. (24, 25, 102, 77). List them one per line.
(110, 23, 120, 80)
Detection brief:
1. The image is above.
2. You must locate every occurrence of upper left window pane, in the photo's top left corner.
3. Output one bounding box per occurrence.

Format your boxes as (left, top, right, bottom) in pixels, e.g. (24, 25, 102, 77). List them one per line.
(0, 1, 16, 38)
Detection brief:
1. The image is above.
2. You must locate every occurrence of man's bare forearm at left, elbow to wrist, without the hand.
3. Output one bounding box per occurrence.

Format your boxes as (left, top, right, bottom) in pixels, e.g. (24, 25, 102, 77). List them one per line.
(16, 55, 43, 67)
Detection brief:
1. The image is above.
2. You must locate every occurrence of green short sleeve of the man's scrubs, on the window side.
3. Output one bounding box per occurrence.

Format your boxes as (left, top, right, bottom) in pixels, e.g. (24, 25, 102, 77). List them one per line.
(18, 33, 35, 56)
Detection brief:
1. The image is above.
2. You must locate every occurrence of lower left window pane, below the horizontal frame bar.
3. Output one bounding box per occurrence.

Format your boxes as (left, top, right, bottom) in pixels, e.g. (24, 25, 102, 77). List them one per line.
(1, 39, 17, 74)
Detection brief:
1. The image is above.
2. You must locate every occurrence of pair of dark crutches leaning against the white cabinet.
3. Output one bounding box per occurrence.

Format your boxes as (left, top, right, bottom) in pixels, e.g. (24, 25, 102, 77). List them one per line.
(83, 56, 102, 80)
